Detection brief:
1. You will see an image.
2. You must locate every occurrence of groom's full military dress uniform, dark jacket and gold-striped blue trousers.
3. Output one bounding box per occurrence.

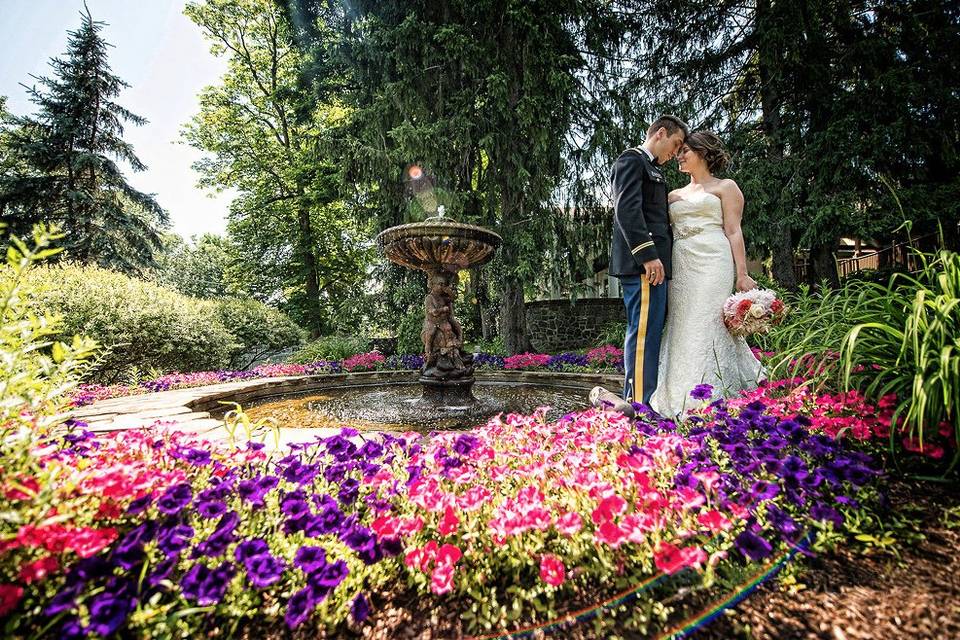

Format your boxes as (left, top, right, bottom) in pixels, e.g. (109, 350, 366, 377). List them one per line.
(609, 148, 673, 404)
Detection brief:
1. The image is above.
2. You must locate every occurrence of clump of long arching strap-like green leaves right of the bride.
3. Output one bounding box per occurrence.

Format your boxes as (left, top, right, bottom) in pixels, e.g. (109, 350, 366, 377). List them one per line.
(755, 251, 960, 474)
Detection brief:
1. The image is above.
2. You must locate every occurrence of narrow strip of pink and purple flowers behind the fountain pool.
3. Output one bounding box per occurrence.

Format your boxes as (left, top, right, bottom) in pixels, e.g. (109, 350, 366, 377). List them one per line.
(72, 345, 623, 407)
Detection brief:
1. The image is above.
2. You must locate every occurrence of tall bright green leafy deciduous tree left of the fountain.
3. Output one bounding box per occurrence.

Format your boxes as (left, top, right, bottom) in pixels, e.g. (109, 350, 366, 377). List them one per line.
(184, 0, 372, 335)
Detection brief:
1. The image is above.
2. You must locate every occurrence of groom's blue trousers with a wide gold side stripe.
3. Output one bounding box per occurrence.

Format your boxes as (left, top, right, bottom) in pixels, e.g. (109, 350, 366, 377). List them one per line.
(620, 275, 667, 404)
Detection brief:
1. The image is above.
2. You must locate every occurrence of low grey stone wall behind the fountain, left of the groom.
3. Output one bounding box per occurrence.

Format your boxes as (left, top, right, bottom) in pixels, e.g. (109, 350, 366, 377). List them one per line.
(527, 298, 627, 353)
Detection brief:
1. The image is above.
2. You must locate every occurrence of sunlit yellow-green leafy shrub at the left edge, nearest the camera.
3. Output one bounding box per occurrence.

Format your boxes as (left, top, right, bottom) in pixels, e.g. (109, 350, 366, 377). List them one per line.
(0, 227, 96, 430)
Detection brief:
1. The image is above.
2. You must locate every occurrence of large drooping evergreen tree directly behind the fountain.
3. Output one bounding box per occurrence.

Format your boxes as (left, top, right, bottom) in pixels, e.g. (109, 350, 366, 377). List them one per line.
(287, 0, 620, 353)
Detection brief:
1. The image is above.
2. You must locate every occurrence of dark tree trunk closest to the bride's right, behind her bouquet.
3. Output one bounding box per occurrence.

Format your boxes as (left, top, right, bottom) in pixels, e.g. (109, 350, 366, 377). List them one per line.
(755, 0, 797, 289)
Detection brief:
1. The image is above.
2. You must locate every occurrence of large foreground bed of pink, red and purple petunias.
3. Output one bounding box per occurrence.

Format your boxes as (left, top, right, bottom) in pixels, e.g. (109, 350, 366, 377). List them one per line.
(0, 384, 877, 638)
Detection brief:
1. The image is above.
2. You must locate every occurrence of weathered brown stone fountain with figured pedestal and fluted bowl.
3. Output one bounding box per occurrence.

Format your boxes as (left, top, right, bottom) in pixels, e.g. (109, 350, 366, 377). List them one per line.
(377, 207, 503, 411)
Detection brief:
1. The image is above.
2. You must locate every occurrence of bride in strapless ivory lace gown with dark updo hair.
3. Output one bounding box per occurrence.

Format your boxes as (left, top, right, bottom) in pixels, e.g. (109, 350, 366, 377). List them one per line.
(650, 131, 764, 418)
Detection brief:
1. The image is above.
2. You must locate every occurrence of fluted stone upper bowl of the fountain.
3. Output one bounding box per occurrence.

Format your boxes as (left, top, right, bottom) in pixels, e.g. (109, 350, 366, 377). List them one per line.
(377, 218, 503, 271)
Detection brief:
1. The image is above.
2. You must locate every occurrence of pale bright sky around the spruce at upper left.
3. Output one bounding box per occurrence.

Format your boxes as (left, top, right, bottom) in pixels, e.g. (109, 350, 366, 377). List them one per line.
(0, 0, 233, 238)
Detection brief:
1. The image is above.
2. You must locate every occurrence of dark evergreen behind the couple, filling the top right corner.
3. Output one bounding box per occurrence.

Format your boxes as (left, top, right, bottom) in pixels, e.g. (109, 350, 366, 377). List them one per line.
(620, 0, 960, 286)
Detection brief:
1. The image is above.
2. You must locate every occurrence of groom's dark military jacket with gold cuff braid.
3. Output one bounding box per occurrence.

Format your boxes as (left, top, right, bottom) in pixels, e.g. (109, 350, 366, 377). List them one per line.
(609, 149, 673, 278)
